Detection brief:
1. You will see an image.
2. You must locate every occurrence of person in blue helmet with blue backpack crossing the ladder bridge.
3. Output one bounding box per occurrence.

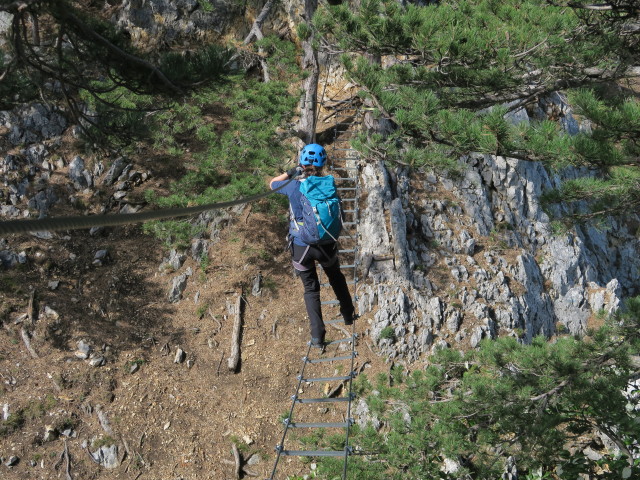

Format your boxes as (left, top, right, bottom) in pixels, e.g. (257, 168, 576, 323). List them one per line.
(269, 143, 355, 348)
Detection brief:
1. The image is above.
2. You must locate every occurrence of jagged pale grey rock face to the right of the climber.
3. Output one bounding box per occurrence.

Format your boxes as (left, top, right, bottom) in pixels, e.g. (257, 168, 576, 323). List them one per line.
(358, 94, 640, 361)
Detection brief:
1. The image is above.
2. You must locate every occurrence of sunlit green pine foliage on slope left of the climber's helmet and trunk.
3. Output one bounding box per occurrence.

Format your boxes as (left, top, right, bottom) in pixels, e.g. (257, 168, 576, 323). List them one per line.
(147, 37, 301, 242)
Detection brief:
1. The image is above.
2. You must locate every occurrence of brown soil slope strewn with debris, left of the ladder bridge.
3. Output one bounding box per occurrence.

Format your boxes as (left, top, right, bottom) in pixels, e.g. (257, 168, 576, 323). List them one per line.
(0, 94, 388, 480)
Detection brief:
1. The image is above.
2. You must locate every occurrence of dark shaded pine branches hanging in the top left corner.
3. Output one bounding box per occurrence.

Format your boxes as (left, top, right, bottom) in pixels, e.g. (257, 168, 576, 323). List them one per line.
(0, 0, 230, 140)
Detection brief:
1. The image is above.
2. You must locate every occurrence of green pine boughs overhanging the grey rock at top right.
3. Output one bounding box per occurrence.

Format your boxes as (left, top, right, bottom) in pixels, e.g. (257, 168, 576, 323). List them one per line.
(314, 0, 640, 218)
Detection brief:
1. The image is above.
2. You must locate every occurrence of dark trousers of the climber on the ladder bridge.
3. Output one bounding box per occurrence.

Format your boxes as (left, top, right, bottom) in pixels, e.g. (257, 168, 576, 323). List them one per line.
(293, 243, 355, 341)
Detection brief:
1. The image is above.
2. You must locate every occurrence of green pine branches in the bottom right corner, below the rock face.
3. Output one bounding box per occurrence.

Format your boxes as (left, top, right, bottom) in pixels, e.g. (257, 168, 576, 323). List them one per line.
(320, 297, 640, 480)
